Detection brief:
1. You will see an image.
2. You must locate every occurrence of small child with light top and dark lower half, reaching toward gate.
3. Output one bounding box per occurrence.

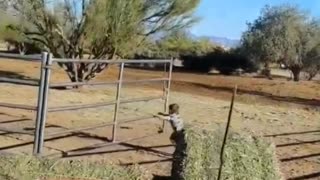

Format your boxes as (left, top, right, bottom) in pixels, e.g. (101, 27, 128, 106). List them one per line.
(158, 104, 187, 180)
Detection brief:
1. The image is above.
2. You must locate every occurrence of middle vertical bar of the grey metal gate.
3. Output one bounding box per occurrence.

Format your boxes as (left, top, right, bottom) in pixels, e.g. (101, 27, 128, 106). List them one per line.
(112, 63, 125, 142)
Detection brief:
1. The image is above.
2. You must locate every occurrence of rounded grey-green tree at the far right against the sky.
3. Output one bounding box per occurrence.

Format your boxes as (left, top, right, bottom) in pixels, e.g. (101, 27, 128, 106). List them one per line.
(242, 5, 320, 81)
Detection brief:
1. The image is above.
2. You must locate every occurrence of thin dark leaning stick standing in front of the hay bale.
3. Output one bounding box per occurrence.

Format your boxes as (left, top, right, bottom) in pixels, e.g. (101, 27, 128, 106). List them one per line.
(217, 85, 238, 180)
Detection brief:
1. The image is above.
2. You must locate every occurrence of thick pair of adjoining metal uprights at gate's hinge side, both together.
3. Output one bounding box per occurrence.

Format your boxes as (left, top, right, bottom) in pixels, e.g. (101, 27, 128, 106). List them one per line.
(33, 53, 52, 155)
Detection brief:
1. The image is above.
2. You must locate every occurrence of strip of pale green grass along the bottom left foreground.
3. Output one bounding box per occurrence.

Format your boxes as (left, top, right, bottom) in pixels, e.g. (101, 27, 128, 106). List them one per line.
(0, 156, 144, 180)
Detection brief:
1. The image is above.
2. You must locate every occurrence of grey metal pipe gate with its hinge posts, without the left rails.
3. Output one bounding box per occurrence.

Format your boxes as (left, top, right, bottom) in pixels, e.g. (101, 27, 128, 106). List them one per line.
(33, 53, 173, 156)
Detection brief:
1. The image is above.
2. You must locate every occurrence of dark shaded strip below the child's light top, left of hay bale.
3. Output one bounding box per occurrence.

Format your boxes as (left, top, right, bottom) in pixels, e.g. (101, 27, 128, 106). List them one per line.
(170, 130, 187, 180)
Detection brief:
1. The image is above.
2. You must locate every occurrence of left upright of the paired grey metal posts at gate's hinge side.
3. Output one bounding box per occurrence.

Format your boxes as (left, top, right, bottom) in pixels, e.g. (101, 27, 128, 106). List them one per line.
(33, 52, 48, 155)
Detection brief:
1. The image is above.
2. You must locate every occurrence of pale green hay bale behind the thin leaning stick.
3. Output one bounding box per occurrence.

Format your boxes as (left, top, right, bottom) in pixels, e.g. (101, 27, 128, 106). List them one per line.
(184, 128, 280, 180)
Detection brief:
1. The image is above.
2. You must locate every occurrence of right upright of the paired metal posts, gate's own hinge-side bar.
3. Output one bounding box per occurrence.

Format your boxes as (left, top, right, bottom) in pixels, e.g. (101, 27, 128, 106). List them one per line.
(35, 54, 52, 155)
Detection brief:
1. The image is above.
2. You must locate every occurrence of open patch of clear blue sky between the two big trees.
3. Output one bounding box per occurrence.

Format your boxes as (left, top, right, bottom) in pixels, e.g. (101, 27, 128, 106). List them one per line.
(191, 0, 320, 39)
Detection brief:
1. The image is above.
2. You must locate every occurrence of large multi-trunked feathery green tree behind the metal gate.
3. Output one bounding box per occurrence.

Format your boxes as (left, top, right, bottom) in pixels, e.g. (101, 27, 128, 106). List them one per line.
(2, 0, 200, 82)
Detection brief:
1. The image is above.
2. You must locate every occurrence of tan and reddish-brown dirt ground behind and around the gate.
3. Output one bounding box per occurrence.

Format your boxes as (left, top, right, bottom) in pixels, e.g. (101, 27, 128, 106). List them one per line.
(0, 60, 320, 180)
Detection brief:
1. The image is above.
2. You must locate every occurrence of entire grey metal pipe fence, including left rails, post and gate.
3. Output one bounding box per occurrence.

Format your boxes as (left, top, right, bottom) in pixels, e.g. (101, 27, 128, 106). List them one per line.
(0, 52, 173, 155)
